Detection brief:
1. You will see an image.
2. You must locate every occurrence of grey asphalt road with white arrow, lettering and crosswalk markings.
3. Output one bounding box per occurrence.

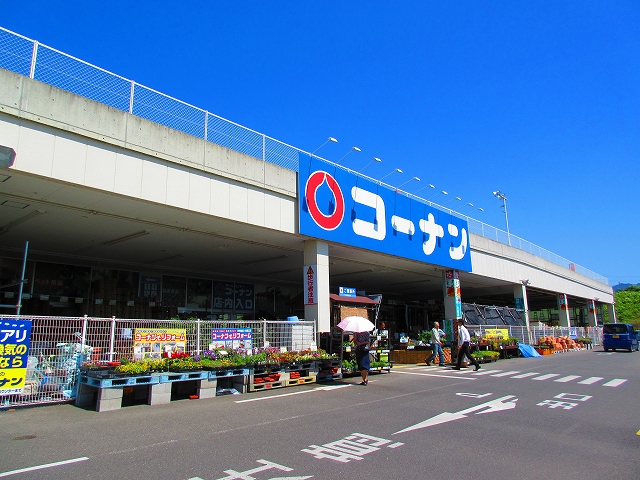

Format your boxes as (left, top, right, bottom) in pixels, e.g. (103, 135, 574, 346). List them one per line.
(0, 350, 640, 480)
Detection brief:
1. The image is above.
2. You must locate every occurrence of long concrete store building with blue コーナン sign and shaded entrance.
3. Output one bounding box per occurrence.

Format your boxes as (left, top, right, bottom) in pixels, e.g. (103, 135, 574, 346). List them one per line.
(0, 31, 615, 333)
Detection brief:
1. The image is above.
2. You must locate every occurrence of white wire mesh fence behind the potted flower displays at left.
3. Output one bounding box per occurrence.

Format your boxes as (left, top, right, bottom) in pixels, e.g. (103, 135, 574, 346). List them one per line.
(0, 315, 316, 409)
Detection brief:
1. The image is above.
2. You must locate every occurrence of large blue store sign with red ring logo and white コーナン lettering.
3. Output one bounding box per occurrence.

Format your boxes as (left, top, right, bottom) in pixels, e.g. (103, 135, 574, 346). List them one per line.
(298, 154, 471, 272)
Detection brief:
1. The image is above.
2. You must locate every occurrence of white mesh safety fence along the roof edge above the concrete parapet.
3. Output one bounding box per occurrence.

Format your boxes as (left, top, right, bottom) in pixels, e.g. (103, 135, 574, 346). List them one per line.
(0, 27, 609, 285)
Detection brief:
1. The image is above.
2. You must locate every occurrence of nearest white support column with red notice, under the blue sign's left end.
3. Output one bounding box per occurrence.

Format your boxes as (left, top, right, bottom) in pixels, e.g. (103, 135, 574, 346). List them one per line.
(303, 240, 331, 333)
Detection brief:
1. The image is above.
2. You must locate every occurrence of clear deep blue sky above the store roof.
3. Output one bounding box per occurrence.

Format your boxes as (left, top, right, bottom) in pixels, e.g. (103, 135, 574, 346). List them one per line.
(0, 0, 640, 285)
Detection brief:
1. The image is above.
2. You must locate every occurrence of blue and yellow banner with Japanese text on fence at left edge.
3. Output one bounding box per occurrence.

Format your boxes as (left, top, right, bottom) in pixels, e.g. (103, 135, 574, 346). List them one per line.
(0, 319, 31, 395)
